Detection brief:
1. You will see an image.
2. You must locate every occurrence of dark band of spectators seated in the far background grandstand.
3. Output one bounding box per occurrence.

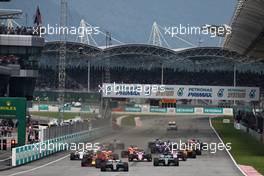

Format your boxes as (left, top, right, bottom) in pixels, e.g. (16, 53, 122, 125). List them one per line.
(36, 66, 264, 90)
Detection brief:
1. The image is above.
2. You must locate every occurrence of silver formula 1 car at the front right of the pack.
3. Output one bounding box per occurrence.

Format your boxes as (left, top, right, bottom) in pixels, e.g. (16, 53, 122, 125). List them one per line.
(153, 153, 179, 166)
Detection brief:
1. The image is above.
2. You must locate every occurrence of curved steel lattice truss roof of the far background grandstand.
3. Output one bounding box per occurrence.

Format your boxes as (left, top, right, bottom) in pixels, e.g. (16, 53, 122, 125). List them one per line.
(43, 41, 261, 65)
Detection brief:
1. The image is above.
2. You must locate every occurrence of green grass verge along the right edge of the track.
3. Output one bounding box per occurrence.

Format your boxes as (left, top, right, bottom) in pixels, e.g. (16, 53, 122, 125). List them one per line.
(212, 117, 264, 175)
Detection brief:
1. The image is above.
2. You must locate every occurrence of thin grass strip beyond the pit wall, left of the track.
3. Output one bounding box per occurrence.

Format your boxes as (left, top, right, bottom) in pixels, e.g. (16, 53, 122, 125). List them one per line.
(29, 111, 95, 120)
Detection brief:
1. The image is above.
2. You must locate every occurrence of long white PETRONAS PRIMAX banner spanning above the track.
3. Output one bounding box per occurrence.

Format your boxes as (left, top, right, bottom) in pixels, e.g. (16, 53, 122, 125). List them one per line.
(99, 83, 259, 101)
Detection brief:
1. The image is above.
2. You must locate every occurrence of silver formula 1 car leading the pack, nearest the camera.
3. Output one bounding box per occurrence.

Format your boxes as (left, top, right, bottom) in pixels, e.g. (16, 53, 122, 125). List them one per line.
(101, 160, 128, 172)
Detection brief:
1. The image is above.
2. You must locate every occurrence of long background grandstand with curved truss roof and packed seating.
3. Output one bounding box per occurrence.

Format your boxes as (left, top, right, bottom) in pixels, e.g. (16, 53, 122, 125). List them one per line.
(37, 42, 264, 91)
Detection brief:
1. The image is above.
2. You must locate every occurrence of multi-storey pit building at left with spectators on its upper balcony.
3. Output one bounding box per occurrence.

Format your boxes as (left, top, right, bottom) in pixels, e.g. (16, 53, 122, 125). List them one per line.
(0, 9, 44, 100)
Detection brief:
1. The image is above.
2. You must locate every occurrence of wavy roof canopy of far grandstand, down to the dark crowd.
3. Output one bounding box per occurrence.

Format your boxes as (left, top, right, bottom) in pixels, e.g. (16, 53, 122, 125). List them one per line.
(40, 41, 264, 72)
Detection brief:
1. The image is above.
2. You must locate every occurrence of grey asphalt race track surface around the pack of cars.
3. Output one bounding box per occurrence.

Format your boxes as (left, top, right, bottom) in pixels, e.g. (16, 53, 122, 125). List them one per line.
(0, 116, 242, 176)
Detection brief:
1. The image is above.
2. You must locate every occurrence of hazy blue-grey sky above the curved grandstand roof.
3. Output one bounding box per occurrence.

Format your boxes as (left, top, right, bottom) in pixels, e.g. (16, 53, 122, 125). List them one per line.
(0, 0, 237, 48)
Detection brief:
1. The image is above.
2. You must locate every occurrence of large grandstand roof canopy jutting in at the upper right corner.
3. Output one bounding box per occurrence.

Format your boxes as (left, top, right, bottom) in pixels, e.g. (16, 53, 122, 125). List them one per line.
(223, 0, 264, 59)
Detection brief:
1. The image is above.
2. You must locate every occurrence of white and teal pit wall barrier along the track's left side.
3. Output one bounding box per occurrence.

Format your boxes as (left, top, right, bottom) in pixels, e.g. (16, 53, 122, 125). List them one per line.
(12, 127, 110, 166)
